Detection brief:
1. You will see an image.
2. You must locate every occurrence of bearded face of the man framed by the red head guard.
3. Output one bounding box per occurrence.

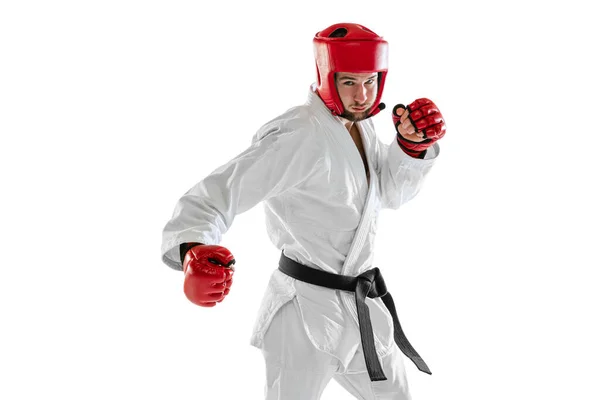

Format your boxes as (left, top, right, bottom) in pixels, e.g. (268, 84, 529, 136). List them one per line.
(335, 72, 377, 121)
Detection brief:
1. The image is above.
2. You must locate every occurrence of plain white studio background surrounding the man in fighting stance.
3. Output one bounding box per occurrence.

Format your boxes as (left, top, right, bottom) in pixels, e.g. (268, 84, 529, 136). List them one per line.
(0, 0, 600, 400)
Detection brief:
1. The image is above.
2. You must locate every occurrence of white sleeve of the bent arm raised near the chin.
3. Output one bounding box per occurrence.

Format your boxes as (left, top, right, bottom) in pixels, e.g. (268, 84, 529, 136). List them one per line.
(375, 137, 440, 210)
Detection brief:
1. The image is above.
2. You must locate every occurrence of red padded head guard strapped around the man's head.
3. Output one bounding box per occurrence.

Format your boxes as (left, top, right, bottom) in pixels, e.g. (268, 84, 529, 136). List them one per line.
(313, 23, 388, 117)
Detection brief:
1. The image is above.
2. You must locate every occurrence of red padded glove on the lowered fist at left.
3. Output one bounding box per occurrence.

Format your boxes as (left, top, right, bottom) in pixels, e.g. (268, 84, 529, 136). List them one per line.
(183, 245, 235, 307)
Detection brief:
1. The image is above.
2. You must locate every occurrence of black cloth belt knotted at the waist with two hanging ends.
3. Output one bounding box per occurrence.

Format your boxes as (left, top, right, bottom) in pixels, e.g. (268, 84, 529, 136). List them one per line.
(279, 252, 431, 381)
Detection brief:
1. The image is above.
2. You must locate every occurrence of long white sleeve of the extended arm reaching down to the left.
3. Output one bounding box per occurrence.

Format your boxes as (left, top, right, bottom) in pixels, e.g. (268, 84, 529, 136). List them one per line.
(161, 126, 318, 270)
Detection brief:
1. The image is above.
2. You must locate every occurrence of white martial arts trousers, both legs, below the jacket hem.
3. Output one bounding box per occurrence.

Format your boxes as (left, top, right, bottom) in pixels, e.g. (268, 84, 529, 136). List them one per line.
(262, 298, 411, 400)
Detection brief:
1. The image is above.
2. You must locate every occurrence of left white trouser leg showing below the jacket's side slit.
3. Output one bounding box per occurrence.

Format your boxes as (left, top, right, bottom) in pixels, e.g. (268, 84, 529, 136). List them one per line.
(262, 299, 338, 400)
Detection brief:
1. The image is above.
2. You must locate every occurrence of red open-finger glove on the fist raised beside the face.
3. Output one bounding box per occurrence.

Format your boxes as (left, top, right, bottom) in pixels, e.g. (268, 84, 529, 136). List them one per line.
(392, 99, 446, 158)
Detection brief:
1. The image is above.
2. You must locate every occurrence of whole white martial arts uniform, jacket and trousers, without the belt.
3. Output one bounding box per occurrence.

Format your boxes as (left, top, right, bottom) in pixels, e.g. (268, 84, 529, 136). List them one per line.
(162, 84, 439, 400)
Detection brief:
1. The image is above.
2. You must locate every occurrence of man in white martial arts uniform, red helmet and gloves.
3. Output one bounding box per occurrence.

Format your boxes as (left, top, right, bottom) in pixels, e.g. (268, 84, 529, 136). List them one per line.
(162, 23, 445, 400)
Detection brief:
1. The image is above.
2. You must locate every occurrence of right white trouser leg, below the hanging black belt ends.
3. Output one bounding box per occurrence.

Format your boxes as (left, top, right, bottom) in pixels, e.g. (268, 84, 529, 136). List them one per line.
(334, 346, 411, 400)
